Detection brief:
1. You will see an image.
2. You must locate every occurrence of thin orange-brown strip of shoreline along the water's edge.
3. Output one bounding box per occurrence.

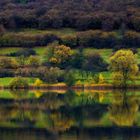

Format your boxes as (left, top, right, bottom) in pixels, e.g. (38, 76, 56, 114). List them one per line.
(0, 84, 140, 91)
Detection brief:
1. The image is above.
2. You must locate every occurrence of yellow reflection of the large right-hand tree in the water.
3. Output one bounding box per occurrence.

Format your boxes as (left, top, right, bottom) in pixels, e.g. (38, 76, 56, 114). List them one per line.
(109, 91, 139, 126)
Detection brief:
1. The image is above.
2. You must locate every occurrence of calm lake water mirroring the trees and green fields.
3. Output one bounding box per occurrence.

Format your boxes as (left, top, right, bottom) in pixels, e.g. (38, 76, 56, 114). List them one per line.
(0, 91, 140, 140)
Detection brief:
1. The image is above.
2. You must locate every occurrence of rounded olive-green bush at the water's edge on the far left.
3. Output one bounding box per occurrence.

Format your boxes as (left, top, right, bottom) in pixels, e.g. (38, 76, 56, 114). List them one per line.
(9, 77, 29, 89)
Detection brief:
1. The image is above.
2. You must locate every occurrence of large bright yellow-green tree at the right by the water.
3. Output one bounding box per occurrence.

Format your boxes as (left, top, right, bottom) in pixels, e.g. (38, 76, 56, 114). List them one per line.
(110, 50, 139, 87)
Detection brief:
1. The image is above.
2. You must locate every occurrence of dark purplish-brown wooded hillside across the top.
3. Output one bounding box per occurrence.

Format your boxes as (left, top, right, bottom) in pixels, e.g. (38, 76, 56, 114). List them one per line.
(0, 0, 140, 31)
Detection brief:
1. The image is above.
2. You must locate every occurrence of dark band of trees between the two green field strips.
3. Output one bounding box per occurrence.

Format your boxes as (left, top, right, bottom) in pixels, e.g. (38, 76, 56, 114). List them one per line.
(0, 30, 140, 49)
